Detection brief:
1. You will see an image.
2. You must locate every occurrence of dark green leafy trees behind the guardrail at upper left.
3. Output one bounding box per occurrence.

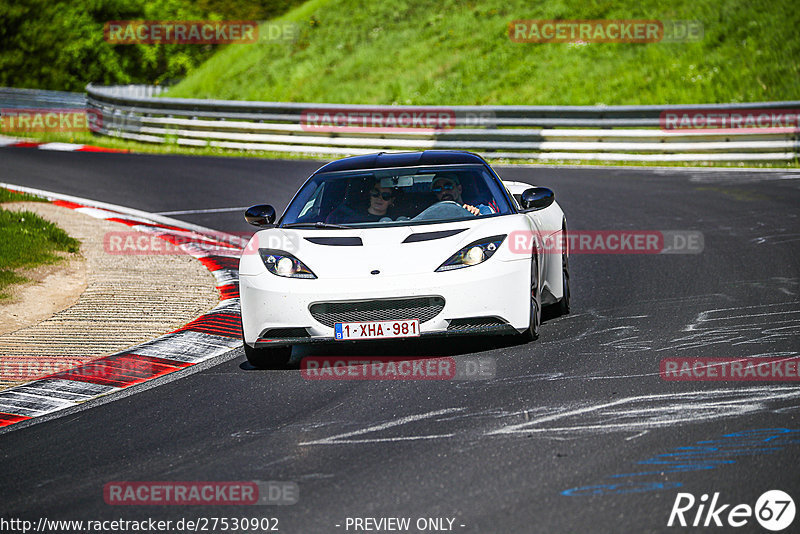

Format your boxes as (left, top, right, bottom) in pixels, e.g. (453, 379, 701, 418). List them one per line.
(0, 0, 302, 91)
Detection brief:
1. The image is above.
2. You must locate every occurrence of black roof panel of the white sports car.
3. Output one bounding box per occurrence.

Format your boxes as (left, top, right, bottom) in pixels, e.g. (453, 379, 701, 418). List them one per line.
(314, 150, 487, 174)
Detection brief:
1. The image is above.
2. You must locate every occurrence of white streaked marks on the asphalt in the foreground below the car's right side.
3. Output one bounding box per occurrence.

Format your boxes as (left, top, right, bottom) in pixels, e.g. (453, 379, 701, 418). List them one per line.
(298, 386, 800, 446)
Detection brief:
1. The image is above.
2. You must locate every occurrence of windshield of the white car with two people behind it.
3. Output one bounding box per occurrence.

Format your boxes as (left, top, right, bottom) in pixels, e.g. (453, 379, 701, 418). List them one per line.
(281, 165, 510, 228)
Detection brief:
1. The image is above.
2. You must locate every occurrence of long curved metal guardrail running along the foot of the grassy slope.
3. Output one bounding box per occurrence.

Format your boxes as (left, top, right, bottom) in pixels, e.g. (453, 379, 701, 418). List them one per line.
(87, 84, 800, 161)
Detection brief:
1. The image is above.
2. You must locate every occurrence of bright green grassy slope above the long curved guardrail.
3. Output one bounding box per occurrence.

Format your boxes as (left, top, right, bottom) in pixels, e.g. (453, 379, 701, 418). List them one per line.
(168, 0, 800, 105)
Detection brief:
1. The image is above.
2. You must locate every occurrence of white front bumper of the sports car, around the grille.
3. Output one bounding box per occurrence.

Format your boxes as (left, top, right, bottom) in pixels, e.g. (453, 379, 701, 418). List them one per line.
(239, 260, 530, 347)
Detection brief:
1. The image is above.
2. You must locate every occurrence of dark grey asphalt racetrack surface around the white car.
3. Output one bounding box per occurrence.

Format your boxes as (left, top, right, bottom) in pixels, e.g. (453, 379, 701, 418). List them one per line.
(0, 149, 800, 533)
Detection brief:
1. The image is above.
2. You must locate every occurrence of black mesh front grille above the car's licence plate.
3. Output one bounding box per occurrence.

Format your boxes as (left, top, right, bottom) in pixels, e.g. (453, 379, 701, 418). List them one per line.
(310, 297, 444, 328)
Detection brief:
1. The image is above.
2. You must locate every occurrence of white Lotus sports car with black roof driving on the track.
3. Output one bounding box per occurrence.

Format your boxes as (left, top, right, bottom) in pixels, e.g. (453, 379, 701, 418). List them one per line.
(239, 150, 569, 367)
